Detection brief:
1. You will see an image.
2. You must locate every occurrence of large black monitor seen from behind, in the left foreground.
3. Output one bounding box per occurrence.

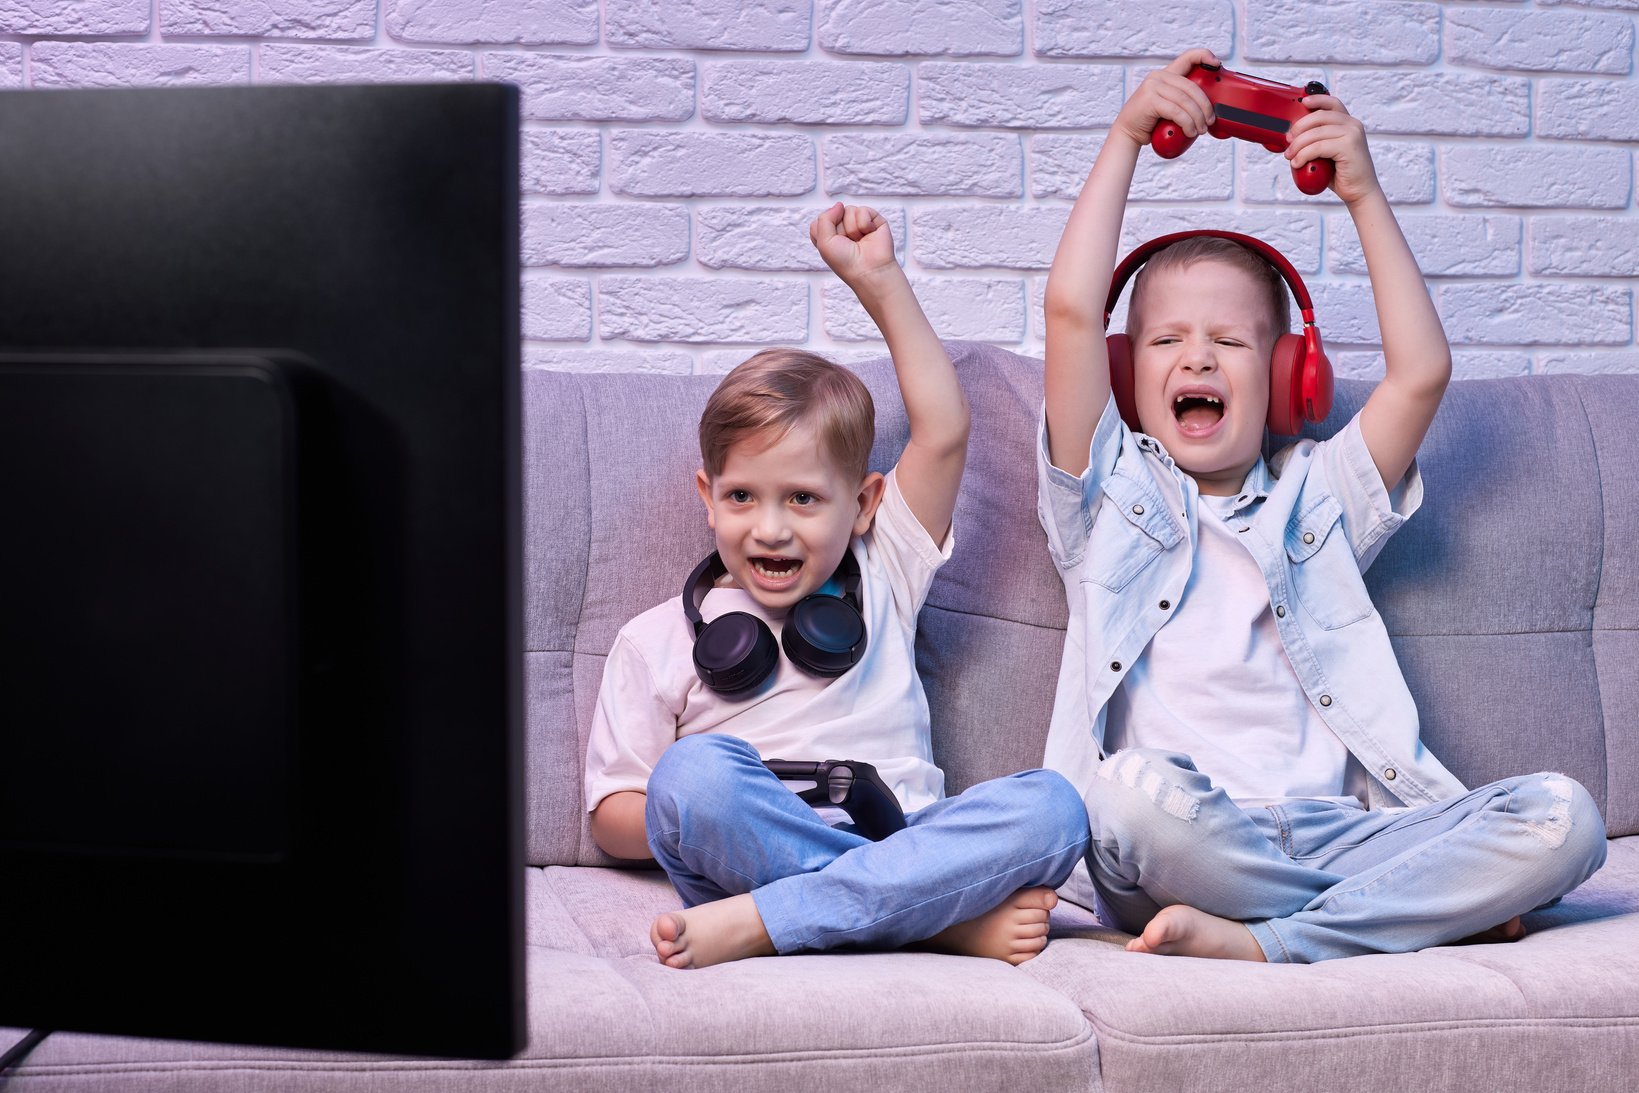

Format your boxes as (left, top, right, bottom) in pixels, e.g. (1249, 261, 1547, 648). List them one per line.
(0, 85, 523, 1057)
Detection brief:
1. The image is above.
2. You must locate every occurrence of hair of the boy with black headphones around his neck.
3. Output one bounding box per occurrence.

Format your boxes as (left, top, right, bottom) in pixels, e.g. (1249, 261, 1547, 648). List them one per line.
(700, 349, 877, 478)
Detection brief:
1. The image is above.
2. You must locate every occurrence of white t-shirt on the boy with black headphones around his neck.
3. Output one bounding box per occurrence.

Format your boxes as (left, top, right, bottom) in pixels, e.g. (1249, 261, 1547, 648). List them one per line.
(585, 472, 956, 813)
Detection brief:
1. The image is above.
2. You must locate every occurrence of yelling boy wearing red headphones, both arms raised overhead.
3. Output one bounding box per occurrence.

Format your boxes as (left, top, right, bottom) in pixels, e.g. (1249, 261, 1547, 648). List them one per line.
(1037, 49, 1605, 962)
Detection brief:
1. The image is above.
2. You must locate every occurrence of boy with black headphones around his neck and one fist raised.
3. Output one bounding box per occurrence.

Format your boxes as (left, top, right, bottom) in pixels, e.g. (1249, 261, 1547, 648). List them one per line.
(585, 205, 1087, 968)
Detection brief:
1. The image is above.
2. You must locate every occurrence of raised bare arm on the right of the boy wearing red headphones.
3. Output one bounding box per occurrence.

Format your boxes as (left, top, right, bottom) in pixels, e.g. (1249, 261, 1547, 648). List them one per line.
(1287, 95, 1451, 488)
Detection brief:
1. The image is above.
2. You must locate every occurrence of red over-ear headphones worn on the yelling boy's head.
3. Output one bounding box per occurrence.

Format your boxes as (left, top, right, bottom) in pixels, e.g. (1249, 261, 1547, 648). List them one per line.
(1105, 231, 1333, 436)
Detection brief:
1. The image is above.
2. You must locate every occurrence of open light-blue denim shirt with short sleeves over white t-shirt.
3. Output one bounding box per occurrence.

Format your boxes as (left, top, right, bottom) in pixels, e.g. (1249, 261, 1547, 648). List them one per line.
(1036, 400, 1464, 808)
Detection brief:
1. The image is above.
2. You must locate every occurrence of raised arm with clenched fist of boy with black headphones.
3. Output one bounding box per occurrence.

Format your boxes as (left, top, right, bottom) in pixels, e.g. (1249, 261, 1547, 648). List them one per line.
(808, 202, 969, 542)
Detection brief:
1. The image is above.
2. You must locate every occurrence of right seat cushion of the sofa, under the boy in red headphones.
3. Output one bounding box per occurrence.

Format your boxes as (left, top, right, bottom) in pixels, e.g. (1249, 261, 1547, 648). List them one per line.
(1021, 837, 1639, 1093)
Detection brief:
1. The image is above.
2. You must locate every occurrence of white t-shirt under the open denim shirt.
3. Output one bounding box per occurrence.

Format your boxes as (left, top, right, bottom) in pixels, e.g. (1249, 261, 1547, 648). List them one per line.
(1106, 495, 1365, 805)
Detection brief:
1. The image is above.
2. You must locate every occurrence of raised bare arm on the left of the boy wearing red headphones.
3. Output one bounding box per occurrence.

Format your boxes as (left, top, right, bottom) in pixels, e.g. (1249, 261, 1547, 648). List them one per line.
(1044, 49, 1218, 475)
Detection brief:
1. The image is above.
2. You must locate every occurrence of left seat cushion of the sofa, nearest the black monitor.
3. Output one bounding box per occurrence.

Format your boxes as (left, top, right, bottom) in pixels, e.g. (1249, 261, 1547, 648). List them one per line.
(0, 867, 1098, 1093)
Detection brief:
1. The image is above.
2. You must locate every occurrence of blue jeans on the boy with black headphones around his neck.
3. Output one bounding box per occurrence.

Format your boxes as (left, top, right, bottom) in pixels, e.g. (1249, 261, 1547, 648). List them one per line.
(644, 732, 1087, 952)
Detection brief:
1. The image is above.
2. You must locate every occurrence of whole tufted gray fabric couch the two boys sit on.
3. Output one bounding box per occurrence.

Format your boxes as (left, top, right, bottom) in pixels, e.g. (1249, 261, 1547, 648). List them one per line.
(12, 344, 1639, 1093)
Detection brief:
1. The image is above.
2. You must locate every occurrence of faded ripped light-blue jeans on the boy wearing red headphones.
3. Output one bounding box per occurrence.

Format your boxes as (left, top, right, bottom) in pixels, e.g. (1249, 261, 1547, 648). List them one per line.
(1087, 749, 1605, 964)
